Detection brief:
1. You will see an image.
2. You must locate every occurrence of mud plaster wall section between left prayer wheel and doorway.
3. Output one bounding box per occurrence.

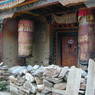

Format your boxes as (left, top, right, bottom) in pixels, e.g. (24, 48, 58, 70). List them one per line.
(27, 17, 50, 65)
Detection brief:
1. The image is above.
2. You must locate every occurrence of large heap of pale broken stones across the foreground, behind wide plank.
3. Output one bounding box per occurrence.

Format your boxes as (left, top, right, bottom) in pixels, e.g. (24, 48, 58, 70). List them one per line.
(9, 65, 87, 95)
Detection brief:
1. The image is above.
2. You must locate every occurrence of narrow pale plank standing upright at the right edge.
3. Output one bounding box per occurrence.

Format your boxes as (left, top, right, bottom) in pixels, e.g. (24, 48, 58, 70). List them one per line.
(85, 59, 95, 95)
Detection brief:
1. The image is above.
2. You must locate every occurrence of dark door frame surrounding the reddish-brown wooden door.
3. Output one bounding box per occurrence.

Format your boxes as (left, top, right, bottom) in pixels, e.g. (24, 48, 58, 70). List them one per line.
(56, 30, 79, 66)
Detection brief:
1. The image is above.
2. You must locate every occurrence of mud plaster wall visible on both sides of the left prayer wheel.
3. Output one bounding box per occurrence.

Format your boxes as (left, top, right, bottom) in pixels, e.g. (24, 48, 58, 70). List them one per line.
(3, 18, 50, 66)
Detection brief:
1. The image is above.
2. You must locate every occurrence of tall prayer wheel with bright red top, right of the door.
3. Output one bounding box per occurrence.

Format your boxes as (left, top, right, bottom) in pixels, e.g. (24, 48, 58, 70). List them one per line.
(78, 8, 95, 64)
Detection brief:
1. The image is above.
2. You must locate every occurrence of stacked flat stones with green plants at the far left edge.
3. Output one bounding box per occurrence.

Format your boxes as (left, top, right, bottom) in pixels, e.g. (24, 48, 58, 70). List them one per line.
(0, 62, 10, 91)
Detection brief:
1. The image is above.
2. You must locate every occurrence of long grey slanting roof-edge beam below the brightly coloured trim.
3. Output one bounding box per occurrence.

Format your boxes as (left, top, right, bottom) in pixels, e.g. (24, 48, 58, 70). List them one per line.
(0, 0, 59, 14)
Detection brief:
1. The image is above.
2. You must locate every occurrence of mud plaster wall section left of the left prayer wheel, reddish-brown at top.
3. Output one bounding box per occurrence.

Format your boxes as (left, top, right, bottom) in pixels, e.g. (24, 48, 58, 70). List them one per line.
(3, 19, 18, 66)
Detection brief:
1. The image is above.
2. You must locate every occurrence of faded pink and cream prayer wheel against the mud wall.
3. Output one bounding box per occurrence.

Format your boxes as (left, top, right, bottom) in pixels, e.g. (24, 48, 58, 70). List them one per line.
(18, 20, 33, 57)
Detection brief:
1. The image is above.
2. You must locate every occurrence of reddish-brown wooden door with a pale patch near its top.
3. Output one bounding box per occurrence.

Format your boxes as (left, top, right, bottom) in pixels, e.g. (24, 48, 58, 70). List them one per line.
(62, 35, 78, 66)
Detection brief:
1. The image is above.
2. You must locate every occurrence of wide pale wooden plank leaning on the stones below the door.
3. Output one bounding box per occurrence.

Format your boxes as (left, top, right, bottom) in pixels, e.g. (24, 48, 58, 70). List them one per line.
(65, 66, 82, 95)
